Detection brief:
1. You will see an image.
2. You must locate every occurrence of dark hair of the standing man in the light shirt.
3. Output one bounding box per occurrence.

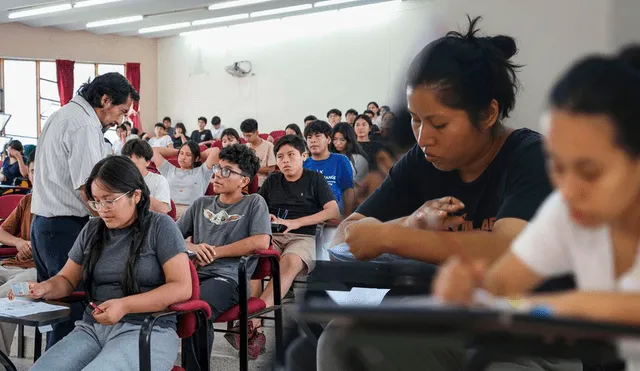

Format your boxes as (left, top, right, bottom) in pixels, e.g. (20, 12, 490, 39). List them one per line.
(78, 72, 140, 108)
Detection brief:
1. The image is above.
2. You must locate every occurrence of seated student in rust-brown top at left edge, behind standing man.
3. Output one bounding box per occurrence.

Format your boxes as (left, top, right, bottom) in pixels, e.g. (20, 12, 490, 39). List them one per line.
(0, 150, 36, 355)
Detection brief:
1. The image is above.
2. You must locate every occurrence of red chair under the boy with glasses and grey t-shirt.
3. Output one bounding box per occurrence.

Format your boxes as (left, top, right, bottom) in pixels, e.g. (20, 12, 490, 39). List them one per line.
(214, 249, 284, 371)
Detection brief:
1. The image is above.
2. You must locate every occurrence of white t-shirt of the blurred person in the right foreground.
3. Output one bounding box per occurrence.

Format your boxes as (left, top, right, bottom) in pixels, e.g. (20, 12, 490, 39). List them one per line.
(511, 192, 640, 371)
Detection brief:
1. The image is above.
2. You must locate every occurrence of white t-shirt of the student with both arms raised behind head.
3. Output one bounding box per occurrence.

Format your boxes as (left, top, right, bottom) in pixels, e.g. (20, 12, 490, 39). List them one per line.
(158, 161, 213, 205)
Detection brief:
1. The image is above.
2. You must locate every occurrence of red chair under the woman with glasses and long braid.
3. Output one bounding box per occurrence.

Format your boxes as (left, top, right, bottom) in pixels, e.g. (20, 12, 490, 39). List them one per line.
(139, 261, 212, 371)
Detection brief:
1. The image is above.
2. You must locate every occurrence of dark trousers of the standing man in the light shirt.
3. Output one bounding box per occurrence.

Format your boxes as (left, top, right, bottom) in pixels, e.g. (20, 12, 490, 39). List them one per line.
(31, 215, 89, 349)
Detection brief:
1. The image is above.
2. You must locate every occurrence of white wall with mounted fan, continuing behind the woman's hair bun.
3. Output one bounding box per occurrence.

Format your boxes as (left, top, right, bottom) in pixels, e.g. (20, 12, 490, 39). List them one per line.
(158, 0, 620, 132)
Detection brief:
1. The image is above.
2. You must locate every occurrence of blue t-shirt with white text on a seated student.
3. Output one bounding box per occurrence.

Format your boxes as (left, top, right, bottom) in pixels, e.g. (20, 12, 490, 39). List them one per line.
(304, 153, 353, 212)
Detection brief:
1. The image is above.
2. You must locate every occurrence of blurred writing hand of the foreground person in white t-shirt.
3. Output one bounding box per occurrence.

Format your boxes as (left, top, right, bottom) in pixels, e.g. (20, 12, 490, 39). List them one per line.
(432, 256, 486, 305)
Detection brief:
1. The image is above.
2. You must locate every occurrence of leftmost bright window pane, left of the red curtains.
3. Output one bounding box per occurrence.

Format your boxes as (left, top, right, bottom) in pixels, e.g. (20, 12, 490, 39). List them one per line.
(4, 60, 38, 143)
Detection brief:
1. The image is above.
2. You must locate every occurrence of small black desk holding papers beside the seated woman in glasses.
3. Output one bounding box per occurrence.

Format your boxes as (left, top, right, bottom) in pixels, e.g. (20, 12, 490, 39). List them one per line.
(0, 302, 71, 371)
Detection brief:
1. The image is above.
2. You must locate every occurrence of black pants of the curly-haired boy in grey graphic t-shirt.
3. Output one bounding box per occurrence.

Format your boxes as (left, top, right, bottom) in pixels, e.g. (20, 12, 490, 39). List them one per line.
(183, 277, 239, 370)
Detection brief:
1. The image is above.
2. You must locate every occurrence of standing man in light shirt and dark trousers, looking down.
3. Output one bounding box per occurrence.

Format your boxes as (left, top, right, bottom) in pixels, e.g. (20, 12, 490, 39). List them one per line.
(31, 73, 140, 349)
